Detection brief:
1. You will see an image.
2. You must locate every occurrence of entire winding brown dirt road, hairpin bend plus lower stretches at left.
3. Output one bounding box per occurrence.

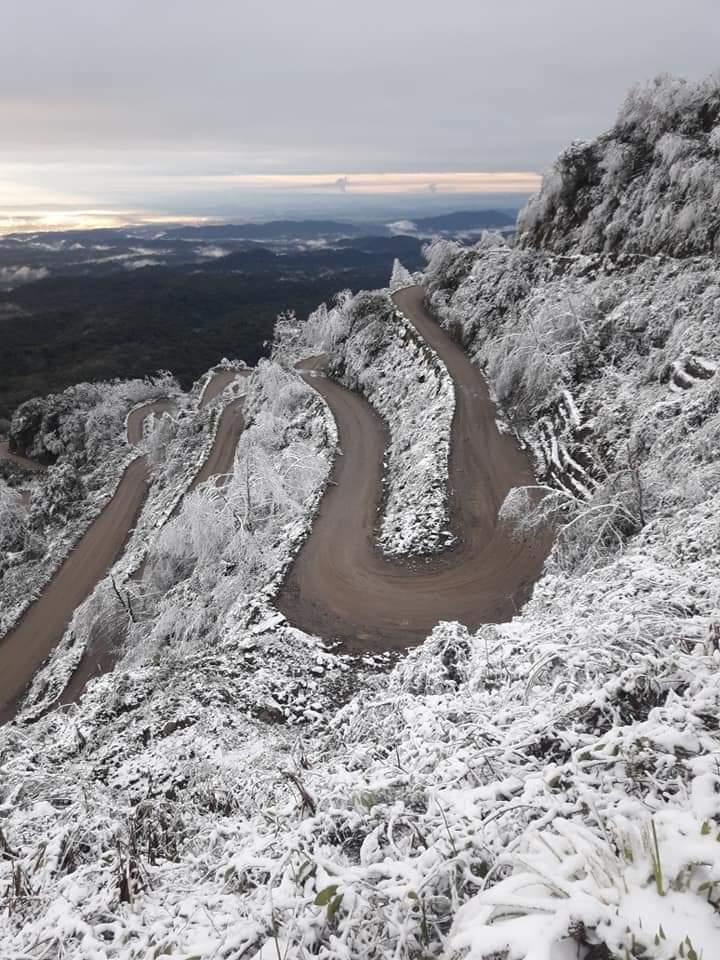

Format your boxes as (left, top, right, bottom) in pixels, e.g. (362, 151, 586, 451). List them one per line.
(0, 278, 550, 719)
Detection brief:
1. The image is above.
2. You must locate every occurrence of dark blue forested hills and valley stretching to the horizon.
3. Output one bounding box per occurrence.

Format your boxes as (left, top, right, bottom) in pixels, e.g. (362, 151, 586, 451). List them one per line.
(0, 210, 514, 418)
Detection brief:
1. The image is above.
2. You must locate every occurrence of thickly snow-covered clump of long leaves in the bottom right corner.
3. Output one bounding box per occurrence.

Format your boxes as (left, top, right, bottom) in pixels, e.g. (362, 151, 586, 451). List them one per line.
(449, 809, 720, 960)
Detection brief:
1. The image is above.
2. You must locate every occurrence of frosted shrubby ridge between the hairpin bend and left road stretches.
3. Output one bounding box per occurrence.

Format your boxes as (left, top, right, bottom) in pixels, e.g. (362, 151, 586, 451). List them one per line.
(15, 362, 336, 718)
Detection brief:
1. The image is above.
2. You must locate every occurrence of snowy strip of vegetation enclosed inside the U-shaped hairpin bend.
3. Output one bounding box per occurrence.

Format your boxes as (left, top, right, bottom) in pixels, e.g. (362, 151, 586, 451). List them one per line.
(278, 286, 455, 556)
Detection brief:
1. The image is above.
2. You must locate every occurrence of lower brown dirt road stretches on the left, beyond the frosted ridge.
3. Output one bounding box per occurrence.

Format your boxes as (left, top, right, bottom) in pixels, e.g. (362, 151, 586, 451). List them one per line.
(0, 370, 249, 723)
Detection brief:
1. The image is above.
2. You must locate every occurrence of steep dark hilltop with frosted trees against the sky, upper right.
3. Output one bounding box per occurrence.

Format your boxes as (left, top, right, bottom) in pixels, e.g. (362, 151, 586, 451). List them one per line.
(518, 75, 720, 256)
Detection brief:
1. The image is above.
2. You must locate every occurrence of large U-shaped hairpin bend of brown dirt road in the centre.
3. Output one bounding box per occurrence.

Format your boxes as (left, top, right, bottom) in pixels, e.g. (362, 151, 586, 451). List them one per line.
(278, 287, 550, 653)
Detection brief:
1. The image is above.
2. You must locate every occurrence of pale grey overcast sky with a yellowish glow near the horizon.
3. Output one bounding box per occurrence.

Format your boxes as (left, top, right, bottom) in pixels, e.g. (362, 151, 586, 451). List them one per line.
(0, 0, 720, 221)
